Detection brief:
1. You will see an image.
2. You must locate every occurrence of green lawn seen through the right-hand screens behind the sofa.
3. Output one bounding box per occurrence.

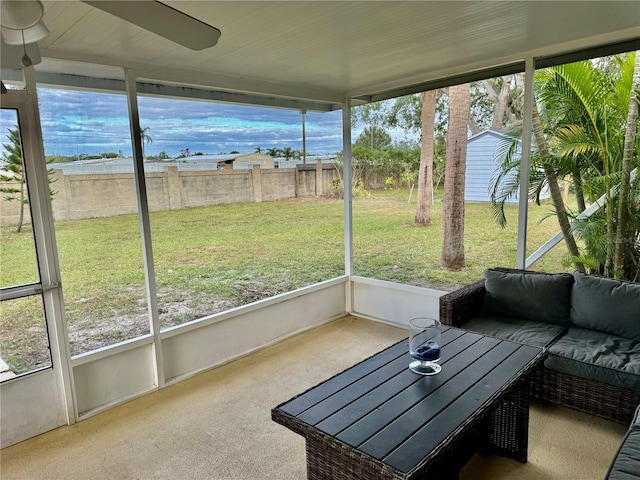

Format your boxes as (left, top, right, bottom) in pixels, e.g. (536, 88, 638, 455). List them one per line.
(353, 190, 564, 290)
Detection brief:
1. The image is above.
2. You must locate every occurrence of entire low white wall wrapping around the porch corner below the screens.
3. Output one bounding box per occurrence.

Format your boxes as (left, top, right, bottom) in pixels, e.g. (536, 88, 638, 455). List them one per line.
(1, 277, 446, 447)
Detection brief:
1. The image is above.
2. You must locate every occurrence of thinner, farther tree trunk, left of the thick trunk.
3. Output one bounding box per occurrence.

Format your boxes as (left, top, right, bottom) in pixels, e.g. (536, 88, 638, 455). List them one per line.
(415, 90, 436, 227)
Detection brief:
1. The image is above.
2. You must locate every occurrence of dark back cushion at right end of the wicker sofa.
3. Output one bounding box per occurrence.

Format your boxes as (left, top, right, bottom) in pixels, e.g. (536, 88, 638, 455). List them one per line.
(571, 272, 640, 341)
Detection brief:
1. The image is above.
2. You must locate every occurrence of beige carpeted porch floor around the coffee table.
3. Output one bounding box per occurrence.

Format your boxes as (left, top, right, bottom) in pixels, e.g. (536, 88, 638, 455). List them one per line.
(0, 317, 626, 480)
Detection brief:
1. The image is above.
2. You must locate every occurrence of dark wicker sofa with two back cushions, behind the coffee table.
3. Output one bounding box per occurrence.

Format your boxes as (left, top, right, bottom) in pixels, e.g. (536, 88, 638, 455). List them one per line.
(440, 268, 640, 424)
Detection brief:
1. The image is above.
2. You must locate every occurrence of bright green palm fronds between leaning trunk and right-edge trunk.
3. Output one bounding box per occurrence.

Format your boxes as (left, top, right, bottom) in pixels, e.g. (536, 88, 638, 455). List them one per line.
(543, 53, 638, 277)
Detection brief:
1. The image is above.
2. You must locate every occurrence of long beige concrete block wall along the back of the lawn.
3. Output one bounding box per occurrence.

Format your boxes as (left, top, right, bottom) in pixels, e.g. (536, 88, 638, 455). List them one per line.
(0, 160, 338, 226)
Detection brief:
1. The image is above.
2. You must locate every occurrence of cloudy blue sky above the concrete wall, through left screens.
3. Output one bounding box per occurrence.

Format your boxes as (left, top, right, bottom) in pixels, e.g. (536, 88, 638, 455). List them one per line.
(0, 88, 342, 157)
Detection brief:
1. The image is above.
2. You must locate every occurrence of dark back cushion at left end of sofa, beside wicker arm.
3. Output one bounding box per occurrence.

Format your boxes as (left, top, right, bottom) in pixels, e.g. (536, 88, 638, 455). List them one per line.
(483, 269, 573, 326)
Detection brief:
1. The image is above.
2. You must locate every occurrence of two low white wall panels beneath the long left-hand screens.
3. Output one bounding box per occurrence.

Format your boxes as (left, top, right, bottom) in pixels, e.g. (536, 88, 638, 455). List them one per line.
(67, 277, 347, 420)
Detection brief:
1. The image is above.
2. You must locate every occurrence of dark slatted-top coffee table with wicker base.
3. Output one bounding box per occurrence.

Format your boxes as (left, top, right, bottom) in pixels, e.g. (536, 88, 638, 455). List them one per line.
(271, 327, 546, 480)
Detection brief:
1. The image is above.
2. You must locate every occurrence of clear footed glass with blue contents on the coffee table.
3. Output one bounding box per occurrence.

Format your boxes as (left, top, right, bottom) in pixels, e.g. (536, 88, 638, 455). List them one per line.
(409, 317, 442, 375)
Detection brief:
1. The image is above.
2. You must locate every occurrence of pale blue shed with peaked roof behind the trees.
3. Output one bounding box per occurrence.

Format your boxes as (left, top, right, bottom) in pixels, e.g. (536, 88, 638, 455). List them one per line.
(464, 130, 519, 203)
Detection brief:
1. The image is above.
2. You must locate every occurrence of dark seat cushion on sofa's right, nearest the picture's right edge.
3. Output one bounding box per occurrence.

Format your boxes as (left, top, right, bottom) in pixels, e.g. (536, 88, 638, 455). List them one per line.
(544, 327, 640, 391)
